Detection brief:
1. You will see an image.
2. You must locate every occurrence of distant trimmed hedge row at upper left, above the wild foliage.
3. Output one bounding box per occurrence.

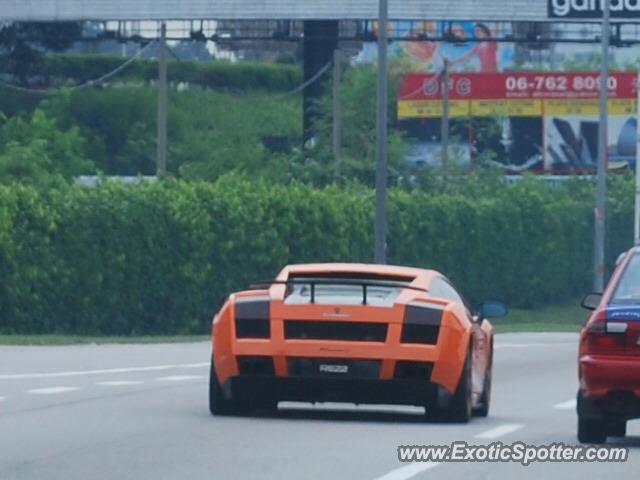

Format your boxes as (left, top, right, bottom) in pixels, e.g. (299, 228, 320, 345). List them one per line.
(0, 54, 302, 92)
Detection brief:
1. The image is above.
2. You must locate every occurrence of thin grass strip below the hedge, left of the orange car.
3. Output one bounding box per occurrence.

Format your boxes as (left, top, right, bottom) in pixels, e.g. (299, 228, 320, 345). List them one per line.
(0, 335, 211, 346)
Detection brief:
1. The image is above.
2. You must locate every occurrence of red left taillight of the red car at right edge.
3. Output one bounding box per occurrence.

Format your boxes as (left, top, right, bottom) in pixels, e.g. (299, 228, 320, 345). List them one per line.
(580, 310, 627, 355)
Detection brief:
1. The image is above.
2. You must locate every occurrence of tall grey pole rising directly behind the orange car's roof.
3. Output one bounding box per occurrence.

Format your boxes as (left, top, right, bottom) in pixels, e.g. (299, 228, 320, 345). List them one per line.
(375, 0, 389, 265)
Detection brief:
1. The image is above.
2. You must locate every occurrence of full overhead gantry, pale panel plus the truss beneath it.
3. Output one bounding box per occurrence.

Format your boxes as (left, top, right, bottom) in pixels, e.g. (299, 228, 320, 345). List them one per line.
(8, 0, 640, 47)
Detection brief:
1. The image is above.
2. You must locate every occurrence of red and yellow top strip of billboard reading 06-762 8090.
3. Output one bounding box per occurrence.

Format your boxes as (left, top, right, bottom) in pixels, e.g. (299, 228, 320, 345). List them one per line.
(398, 72, 638, 118)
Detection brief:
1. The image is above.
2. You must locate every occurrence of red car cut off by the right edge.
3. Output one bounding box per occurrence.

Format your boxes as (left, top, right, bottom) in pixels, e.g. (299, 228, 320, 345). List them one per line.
(578, 248, 640, 443)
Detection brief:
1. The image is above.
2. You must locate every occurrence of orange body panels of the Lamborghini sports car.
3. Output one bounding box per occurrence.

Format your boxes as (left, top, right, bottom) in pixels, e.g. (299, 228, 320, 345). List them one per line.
(212, 264, 493, 398)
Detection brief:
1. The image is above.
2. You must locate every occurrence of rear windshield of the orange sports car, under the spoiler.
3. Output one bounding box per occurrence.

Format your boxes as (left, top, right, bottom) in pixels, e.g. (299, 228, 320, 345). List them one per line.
(285, 276, 411, 306)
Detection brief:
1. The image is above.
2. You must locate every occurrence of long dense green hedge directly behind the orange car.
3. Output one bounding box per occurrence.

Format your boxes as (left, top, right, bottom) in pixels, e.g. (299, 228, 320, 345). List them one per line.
(0, 177, 633, 335)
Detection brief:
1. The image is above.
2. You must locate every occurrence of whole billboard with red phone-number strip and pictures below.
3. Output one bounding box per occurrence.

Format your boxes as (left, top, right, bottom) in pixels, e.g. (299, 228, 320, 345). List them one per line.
(398, 72, 638, 173)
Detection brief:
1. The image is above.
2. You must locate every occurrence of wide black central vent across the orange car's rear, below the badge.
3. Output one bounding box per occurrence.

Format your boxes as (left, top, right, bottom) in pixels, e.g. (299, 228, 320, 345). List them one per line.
(284, 320, 389, 342)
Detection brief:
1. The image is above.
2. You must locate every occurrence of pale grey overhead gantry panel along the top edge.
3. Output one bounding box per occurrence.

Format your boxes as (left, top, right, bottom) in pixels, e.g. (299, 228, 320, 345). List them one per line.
(0, 0, 640, 22)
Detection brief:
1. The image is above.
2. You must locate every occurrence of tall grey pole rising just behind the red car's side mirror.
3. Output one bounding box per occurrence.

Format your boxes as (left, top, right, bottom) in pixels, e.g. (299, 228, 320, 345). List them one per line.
(593, 0, 611, 292)
